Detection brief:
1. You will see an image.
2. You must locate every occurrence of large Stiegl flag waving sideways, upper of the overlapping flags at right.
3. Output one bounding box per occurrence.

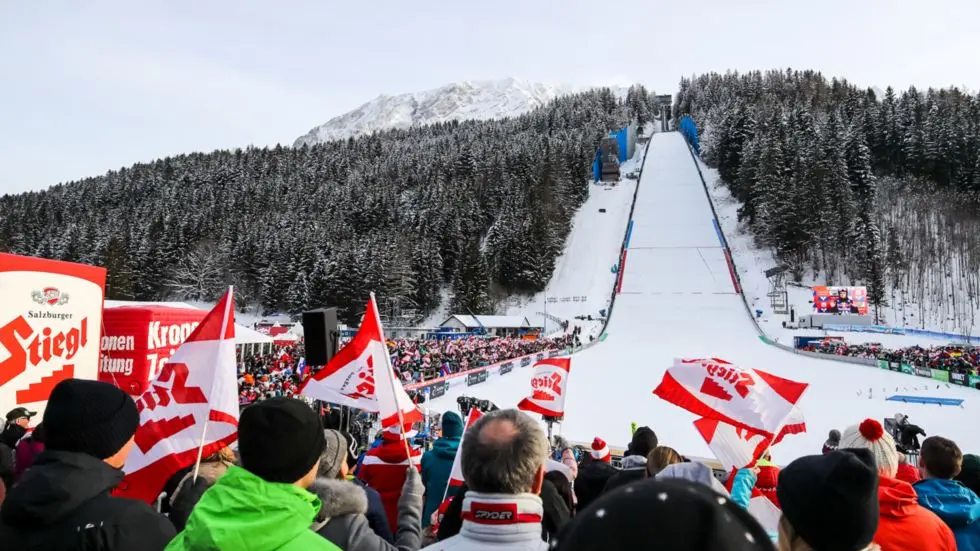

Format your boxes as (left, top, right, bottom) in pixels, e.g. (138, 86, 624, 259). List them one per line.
(653, 358, 809, 437)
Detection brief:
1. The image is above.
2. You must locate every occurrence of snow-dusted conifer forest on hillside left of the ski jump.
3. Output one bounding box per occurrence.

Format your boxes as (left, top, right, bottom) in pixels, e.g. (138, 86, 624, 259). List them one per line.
(0, 88, 660, 321)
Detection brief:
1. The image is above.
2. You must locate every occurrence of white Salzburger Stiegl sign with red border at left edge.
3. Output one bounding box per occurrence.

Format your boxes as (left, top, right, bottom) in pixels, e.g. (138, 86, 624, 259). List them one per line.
(0, 253, 106, 422)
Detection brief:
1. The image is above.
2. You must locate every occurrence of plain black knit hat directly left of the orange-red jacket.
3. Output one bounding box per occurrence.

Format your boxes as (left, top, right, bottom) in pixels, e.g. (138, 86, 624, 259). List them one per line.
(776, 449, 879, 551)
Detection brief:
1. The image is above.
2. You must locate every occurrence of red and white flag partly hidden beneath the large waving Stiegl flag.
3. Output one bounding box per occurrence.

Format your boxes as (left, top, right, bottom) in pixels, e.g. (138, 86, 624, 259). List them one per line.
(694, 407, 806, 471)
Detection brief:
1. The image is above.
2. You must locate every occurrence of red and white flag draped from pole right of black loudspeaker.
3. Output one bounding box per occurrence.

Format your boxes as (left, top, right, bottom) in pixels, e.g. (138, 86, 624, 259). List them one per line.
(300, 294, 423, 427)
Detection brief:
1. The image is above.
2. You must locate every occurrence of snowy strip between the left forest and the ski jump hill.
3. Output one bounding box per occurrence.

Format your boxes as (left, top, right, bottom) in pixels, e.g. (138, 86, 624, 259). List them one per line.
(507, 148, 646, 336)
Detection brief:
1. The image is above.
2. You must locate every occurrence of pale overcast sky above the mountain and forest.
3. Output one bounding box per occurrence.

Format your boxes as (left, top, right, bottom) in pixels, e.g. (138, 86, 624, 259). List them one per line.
(0, 0, 980, 195)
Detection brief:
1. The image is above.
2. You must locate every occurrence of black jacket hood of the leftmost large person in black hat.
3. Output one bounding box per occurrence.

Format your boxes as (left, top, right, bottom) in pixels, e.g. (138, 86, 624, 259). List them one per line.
(0, 451, 123, 529)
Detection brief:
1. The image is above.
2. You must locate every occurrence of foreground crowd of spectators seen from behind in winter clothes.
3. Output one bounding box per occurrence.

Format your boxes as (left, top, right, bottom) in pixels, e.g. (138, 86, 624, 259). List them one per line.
(7, 379, 980, 551)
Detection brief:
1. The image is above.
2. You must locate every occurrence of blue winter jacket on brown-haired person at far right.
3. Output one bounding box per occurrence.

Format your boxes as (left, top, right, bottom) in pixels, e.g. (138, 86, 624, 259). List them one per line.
(914, 479, 980, 551)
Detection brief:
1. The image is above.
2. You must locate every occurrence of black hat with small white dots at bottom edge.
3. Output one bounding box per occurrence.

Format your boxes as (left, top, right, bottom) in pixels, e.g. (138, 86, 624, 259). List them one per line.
(552, 479, 773, 551)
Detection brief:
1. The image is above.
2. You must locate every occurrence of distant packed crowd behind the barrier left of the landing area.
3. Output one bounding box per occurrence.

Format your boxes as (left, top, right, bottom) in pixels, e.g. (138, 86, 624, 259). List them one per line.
(238, 333, 578, 406)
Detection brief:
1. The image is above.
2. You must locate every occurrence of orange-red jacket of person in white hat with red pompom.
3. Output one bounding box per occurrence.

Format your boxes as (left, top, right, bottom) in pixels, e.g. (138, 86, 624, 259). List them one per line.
(874, 476, 956, 551)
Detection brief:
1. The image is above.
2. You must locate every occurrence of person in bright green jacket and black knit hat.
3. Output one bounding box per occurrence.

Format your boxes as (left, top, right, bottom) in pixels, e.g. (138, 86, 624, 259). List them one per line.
(167, 397, 339, 551)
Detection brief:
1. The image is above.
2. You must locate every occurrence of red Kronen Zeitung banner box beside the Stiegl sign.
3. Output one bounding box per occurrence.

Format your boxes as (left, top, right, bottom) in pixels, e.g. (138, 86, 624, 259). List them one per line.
(99, 305, 207, 396)
